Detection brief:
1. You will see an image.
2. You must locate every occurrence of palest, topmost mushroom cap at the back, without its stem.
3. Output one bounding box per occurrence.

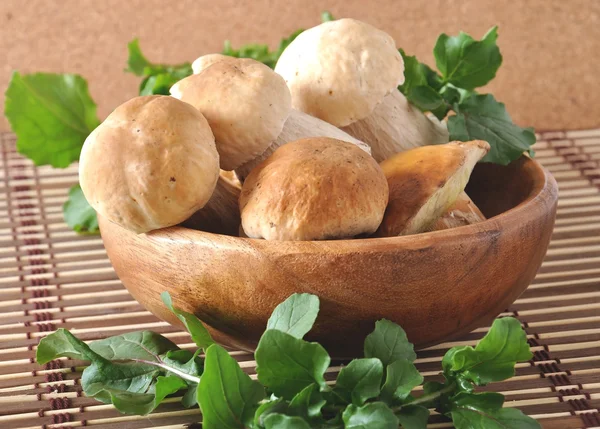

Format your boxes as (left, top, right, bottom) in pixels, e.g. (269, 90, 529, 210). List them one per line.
(275, 19, 404, 127)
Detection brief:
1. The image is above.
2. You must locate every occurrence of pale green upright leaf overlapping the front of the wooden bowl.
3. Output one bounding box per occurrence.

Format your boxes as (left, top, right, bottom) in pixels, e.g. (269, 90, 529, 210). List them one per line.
(267, 293, 319, 338)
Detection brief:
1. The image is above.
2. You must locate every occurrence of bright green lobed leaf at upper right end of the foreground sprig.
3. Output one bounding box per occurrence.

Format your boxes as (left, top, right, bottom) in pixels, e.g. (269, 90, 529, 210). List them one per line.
(442, 317, 532, 385)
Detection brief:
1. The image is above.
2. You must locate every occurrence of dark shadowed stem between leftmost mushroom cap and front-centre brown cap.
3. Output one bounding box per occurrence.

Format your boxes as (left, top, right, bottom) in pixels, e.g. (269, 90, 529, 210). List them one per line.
(182, 177, 241, 236)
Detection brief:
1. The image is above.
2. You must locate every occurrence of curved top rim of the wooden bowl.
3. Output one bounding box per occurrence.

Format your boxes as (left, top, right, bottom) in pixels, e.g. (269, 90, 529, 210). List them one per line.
(132, 155, 558, 253)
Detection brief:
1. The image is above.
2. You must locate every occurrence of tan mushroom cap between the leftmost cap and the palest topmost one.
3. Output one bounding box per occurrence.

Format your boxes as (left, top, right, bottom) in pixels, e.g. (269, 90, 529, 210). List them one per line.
(171, 59, 292, 170)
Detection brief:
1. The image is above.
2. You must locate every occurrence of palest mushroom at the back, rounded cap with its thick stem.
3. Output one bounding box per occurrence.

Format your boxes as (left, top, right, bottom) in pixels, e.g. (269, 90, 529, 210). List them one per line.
(275, 19, 485, 229)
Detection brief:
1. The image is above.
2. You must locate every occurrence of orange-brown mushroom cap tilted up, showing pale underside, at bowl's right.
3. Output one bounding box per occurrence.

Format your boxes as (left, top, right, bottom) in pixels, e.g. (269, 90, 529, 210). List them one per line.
(375, 140, 490, 237)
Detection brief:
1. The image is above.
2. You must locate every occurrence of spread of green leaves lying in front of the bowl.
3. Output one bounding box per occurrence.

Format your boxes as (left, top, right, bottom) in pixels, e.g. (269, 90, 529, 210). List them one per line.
(37, 292, 540, 429)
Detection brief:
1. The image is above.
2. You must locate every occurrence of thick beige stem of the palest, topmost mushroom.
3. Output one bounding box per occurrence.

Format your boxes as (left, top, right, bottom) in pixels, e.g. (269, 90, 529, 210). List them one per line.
(342, 90, 449, 162)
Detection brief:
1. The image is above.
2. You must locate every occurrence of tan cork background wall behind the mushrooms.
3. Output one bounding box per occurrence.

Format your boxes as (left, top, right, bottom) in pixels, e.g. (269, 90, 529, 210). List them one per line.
(0, 0, 600, 130)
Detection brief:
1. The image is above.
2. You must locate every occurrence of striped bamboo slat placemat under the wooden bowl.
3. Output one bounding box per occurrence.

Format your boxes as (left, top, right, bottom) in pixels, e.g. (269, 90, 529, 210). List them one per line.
(0, 129, 600, 429)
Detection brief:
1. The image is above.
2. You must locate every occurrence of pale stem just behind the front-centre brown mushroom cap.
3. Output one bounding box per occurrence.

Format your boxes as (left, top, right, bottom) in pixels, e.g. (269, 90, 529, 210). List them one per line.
(235, 109, 371, 182)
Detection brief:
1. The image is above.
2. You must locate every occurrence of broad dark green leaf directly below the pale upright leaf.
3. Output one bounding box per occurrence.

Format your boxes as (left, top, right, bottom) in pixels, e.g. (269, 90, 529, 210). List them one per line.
(254, 329, 331, 400)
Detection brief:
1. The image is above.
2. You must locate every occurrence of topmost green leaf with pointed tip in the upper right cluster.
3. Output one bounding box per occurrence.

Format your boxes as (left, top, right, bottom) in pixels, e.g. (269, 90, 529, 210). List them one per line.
(433, 27, 502, 89)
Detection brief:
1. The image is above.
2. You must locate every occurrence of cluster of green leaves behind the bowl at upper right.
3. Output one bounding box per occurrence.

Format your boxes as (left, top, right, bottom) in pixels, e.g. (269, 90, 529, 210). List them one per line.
(398, 27, 535, 165)
